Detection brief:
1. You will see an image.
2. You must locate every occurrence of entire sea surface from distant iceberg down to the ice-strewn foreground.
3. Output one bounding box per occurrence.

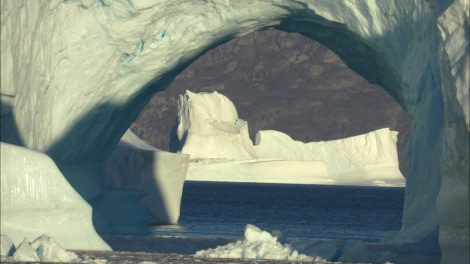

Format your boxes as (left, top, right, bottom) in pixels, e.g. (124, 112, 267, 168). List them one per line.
(2, 181, 418, 264)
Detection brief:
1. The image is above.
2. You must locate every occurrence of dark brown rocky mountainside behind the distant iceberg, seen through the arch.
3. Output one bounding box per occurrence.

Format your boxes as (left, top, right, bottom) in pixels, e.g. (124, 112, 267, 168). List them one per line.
(131, 30, 411, 174)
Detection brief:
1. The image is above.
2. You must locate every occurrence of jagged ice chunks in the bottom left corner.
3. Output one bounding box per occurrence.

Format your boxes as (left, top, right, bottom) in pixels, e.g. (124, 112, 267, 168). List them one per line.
(1, 234, 78, 262)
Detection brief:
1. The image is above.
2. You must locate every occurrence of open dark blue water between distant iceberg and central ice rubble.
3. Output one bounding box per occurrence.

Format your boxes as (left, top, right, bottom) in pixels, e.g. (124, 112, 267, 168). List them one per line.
(154, 182, 404, 241)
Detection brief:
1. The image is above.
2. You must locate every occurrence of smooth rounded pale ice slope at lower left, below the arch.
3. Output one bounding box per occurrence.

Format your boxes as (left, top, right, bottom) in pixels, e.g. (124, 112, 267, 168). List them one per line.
(0, 142, 110, 250)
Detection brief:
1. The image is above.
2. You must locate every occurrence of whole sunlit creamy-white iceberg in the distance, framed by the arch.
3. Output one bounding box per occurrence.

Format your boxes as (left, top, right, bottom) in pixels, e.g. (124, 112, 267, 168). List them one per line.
(177, 91, 405, 187)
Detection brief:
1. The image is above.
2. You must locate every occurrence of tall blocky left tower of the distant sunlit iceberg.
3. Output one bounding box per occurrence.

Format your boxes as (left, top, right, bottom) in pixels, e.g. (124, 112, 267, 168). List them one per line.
(177, 91, 256, 160)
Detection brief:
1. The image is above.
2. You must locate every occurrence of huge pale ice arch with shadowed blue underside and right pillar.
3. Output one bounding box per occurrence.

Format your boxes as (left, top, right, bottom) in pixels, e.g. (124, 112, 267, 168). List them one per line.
(1, 0, 470, 263)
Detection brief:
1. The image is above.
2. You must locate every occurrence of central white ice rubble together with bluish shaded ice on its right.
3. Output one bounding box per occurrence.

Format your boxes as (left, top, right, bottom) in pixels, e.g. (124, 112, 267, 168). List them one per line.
(194, 224, 390, 263)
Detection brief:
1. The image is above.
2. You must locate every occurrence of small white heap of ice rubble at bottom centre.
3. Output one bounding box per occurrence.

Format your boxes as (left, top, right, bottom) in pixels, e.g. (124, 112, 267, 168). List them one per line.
(195, 224, 326, 262)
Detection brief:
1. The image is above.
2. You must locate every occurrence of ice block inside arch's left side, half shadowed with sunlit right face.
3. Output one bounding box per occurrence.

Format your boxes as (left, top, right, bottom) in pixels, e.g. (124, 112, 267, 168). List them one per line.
(100, 130, 189, 224)
